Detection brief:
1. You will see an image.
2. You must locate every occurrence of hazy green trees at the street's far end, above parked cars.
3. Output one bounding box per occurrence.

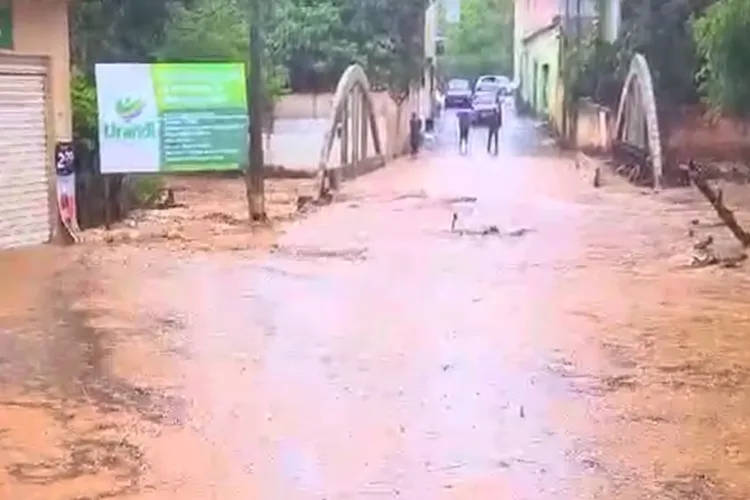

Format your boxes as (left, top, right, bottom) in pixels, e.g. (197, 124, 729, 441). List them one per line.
(440, 0, 513, 79)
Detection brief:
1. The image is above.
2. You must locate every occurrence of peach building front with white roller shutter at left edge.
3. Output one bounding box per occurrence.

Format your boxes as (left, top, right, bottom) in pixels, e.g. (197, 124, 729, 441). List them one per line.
(0, 0, 72, 249)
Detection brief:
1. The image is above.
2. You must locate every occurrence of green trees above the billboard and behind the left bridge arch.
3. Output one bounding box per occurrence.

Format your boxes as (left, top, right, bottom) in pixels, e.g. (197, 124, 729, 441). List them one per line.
(72, 0, 427, 105)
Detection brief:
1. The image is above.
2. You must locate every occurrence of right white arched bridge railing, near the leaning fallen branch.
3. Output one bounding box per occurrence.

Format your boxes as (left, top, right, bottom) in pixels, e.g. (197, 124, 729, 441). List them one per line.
(614, 54, 663, 189)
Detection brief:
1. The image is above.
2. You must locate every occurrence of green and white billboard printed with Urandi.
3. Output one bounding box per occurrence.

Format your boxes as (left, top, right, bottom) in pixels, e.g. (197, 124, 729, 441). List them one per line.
(95, 63, 249, 174)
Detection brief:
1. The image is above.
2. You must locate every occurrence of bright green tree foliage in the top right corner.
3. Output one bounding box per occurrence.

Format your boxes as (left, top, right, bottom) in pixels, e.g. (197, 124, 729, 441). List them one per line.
(694, 0, 750, 118)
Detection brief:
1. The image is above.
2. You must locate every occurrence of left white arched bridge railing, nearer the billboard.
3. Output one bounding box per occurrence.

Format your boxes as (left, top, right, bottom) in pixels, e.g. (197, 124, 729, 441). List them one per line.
(318, 64, 383, 194)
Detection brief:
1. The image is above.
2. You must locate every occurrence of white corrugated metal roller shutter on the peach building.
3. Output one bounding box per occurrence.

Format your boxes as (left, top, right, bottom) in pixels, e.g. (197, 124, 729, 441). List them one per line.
(0, 58, 51, 249)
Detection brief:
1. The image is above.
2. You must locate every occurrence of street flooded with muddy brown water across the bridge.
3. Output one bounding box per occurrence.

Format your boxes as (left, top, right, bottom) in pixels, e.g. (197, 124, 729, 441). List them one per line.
(0, 113, 750, 500)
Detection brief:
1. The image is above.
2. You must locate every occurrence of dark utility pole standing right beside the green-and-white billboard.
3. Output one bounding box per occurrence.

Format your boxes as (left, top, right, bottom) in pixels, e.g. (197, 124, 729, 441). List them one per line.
(245, 0, 267, 222)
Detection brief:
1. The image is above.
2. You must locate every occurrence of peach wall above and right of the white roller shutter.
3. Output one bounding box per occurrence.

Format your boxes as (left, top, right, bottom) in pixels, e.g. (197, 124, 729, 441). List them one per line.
(0, 0, 73, 140)
